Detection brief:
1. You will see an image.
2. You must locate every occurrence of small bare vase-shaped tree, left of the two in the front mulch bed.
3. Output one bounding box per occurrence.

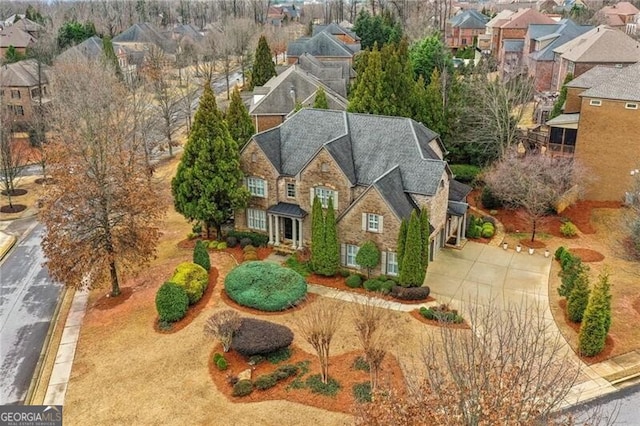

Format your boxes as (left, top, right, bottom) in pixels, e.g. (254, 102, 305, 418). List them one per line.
(297, 298, 342, 384)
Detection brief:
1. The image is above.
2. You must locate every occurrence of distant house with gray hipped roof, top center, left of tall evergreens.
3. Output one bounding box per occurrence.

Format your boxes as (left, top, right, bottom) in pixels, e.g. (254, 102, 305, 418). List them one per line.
(287, 31, 360, 65)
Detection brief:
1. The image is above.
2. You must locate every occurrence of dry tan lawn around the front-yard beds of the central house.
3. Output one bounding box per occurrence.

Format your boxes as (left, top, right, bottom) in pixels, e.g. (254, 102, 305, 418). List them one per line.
(60, 154, 437, 426)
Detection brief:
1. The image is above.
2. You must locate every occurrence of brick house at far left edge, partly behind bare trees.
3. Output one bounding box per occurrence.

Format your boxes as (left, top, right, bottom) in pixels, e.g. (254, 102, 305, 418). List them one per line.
(0, 59, 51, 128)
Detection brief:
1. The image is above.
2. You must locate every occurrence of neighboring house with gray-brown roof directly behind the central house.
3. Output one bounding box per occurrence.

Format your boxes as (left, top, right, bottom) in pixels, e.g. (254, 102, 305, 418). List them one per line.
(249, 65, 347, 132)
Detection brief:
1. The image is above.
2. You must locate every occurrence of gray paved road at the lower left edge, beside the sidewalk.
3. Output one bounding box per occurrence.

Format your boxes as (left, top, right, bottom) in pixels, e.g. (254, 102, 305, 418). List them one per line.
(0, 219, 62, 405)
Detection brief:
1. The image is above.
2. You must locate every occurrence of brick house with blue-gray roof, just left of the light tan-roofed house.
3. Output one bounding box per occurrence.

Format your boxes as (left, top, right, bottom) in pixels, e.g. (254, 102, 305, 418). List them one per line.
(523, 19, 593, 92)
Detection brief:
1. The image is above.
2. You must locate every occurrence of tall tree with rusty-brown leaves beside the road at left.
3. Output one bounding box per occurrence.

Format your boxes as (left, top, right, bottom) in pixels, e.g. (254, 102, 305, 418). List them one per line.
(40, 58, 164, 296)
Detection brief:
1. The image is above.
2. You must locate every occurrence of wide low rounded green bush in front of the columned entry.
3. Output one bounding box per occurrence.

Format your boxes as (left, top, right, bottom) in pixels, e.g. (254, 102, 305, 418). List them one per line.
(224, 262, 307, 312)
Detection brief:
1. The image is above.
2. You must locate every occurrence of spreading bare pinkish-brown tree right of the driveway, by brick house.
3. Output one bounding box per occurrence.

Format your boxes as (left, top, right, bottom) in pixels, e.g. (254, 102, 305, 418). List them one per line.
(484, 151, 584, 241)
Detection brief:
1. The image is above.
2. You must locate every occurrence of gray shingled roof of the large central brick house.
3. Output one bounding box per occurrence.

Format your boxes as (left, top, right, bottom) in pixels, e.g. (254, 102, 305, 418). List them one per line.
(254, 109, 446, 201)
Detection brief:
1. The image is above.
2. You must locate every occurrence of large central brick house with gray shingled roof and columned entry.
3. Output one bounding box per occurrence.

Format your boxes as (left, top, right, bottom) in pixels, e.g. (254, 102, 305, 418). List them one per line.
(235, 109, 471, 275)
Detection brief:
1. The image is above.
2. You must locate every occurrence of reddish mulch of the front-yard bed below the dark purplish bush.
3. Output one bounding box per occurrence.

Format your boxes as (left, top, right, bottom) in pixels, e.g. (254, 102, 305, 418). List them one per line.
(208, 345, 405, 412)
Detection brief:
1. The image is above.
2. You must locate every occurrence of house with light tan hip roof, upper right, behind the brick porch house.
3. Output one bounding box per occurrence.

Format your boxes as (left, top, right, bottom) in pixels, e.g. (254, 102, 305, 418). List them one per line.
(551, 25, 640, 90)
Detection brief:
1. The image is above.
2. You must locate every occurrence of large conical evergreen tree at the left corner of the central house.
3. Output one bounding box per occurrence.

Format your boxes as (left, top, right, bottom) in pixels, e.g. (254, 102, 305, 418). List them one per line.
(171, 81, 250, 238)
